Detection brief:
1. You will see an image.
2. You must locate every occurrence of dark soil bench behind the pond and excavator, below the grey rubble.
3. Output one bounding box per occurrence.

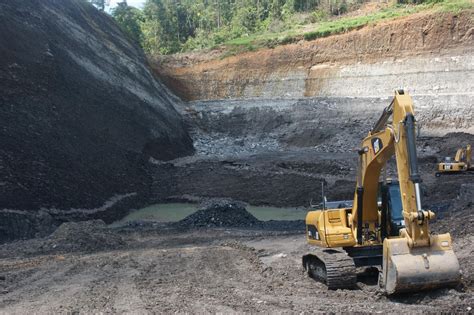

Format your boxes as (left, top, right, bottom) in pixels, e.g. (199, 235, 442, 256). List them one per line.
(152, 132, 474, 209)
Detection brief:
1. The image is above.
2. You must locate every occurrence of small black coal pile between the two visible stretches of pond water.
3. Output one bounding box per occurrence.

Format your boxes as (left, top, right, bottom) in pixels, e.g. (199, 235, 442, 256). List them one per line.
(175, 199, 263, 228)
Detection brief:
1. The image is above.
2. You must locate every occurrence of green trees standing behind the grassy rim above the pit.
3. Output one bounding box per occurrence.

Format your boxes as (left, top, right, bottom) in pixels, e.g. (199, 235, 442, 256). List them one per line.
(136, 0, 352, 54)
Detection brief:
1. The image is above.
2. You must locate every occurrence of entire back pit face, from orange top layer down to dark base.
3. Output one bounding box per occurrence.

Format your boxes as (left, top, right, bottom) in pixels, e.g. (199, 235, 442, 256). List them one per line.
(146, 13, 474, 214)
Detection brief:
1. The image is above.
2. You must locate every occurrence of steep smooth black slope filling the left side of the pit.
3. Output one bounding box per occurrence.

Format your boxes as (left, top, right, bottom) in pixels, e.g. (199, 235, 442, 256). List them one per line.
(0, 0, 194, 218)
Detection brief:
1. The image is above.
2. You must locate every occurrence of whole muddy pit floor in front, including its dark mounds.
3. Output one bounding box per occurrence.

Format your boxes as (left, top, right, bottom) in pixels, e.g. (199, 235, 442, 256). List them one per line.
(0, 184, 474, 314)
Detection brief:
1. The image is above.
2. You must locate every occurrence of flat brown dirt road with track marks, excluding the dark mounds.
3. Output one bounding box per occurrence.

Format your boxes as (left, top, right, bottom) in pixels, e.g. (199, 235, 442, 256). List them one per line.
(0, 229, 474, 314)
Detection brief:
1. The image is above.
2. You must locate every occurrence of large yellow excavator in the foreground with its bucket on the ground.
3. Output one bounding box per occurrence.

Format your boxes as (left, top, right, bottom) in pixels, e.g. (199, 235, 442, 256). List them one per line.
(303, 90, 461, 294)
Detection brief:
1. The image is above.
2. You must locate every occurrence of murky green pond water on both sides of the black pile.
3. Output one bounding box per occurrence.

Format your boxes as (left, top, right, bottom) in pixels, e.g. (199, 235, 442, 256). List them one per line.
(114, 203, 306, 225)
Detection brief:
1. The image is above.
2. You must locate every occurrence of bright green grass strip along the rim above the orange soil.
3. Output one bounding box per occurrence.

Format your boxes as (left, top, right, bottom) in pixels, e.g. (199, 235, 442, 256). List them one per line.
(221, 0, 474, 58)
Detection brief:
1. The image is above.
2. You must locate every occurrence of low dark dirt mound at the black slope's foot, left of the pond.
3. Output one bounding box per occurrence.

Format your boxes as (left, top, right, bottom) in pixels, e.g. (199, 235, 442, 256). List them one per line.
(40, 220, 125, 252)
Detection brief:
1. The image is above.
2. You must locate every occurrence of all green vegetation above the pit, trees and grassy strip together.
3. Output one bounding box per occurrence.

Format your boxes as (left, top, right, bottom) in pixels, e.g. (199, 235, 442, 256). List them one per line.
(103, 0, 474, 57)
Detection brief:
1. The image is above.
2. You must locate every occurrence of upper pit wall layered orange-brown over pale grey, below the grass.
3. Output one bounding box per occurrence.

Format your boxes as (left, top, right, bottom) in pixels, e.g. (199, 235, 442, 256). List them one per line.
(156, 12, 474, 135)
